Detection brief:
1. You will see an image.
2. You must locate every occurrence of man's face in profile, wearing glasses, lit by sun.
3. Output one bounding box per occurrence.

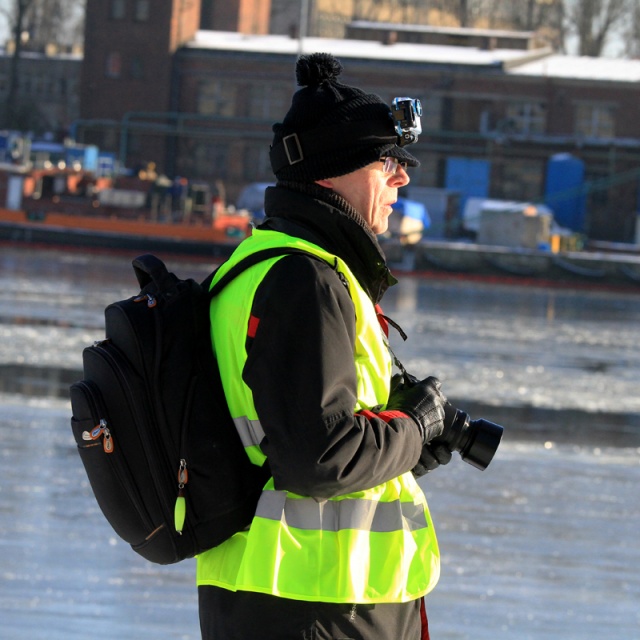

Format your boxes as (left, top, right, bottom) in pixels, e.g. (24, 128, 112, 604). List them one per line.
(318, 162, 409, 235)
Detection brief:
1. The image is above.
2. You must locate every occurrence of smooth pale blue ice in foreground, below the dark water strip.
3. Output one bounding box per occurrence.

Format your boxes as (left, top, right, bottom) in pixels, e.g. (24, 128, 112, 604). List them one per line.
(0, 398, 640, 640)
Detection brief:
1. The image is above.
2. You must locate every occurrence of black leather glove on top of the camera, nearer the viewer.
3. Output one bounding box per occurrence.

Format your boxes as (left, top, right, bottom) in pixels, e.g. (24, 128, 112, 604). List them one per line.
(387, 374, 447, 444)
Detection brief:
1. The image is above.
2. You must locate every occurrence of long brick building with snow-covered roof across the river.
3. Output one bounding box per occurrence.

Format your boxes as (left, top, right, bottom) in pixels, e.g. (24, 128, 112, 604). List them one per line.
(78, 0, 640, 241)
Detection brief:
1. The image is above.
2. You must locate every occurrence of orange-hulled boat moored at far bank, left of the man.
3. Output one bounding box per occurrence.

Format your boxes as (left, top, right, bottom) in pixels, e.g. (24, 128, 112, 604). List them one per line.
(0, 164, 251, 257)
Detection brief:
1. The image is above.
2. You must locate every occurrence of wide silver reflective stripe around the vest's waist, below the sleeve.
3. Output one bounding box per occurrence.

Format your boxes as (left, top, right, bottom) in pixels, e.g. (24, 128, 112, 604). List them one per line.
(256, 491, 428, 533)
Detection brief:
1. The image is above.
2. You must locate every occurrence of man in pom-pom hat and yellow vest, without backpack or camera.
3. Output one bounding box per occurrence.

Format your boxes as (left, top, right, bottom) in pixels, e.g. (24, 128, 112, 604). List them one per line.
(198, 54, 451, 640)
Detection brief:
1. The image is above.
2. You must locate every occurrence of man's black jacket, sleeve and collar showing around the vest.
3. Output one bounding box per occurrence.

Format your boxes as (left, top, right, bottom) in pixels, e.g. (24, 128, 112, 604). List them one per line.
(243, 185, 422, 498)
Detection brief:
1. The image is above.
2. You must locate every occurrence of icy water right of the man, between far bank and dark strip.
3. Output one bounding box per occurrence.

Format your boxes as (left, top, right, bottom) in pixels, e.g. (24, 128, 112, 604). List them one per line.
(385, 278, 640, 413)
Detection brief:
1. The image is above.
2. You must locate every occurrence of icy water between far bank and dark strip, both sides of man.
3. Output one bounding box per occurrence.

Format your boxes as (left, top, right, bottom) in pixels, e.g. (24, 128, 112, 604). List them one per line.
(5, 249, 640, 413)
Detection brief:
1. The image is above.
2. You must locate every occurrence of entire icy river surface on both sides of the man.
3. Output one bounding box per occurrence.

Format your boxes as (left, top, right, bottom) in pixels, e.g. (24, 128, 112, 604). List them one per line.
(0, 248, 640, 640)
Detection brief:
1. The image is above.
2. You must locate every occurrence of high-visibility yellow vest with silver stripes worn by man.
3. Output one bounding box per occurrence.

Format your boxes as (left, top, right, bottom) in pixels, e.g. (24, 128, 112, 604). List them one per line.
(197, 230, 440, 603)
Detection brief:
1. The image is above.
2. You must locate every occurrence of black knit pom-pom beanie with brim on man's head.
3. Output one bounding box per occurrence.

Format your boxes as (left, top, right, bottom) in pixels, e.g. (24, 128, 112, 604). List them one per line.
(269, 53, 420, 182)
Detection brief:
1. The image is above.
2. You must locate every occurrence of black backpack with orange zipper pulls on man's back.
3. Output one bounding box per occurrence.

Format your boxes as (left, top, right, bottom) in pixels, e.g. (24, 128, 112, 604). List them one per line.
(70, 247, 309, 564)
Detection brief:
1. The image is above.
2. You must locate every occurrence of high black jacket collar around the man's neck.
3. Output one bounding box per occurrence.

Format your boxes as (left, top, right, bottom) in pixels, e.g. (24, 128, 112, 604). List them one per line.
(260, 182, 397, 303)
